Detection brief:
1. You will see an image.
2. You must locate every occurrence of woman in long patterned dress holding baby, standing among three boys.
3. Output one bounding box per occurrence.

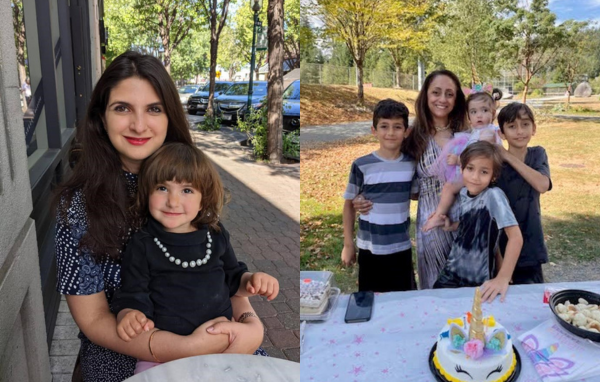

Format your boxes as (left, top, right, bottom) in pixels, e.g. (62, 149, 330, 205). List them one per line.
(353, 70, 468, 289)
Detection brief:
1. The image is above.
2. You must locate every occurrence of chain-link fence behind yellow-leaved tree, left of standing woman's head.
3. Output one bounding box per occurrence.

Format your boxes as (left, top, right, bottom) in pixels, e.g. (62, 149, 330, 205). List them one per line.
(300, 63, 418, 90)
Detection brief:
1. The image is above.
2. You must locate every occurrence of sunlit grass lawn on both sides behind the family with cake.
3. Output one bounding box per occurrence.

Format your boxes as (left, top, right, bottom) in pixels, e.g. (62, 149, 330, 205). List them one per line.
(300, 88, 600, 292)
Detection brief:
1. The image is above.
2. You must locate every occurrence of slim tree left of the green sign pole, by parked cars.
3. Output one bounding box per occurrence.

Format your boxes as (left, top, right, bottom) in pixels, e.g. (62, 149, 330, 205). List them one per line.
(201, 0, 229, 117)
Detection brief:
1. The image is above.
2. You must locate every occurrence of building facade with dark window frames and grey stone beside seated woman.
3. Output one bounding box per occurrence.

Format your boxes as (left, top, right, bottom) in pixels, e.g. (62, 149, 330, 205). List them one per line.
(0, 0, 103, 382)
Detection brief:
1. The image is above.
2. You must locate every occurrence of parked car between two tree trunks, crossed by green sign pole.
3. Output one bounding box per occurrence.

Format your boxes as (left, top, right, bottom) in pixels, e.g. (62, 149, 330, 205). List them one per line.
(216, 81, 268, 123)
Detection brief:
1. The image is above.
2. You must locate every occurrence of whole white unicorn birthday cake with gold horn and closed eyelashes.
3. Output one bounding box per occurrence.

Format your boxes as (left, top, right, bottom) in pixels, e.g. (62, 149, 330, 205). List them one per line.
(433, 288, 517, 382)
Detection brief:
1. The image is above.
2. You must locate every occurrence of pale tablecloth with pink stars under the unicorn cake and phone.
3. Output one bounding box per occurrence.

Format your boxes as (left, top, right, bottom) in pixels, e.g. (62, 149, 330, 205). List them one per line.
(300, 281, 600, 382)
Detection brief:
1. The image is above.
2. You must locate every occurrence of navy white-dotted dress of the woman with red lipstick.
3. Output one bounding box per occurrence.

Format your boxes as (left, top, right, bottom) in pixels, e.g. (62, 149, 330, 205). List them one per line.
(55, 172, 137, 382)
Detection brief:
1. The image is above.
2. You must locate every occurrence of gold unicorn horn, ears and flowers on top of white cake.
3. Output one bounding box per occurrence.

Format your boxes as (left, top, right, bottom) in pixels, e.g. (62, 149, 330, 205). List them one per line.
(442, 288, 510, 359)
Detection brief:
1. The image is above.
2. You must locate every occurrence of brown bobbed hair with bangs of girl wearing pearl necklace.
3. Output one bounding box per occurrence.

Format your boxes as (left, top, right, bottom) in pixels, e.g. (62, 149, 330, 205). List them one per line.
(135, 143, 225, 231)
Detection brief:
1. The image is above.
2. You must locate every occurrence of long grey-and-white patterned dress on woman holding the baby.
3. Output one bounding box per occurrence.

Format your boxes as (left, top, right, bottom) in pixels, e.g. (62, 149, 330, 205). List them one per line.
(416, 137, 460, 289)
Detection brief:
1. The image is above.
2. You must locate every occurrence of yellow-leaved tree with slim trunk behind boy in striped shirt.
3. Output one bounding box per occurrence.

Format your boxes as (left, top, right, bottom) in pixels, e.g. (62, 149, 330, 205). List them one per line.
(316, 0, 400, 105)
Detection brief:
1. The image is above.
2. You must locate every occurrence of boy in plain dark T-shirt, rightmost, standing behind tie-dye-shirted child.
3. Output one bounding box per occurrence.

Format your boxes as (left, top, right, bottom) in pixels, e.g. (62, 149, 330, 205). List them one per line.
(498, 102, 552, 284)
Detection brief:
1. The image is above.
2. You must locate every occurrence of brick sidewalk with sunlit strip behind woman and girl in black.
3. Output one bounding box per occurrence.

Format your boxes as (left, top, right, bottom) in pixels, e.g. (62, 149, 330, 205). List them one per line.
(50, 127, 300, 382)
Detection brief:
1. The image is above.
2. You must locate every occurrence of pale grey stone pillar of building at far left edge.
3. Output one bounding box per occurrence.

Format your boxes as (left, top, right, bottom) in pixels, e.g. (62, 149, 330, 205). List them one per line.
(0, 0, 52, 381)
